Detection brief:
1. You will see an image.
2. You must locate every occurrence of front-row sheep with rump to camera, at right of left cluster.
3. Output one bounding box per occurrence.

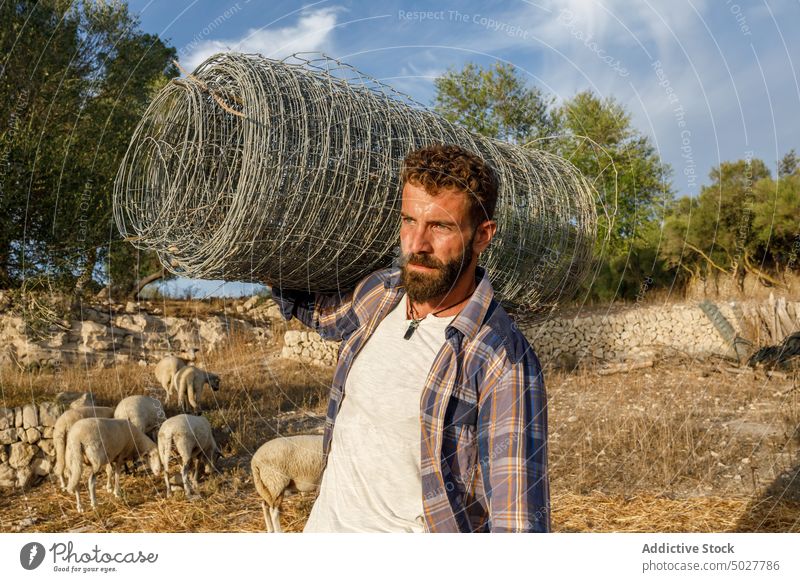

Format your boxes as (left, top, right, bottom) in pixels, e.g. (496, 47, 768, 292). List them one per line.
(158, 414, 222, 497)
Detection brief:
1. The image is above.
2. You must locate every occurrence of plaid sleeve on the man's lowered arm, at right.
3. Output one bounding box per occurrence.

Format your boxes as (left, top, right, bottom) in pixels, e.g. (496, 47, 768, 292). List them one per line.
(478, 349, 550, 532)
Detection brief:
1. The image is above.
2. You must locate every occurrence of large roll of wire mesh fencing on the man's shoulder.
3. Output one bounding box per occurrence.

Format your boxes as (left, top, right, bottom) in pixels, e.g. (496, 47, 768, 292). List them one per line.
(114, 53, 597, 309)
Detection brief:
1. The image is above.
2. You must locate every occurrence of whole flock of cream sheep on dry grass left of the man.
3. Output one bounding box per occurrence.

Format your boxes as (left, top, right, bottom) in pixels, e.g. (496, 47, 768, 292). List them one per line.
(53, 356, 323, 532)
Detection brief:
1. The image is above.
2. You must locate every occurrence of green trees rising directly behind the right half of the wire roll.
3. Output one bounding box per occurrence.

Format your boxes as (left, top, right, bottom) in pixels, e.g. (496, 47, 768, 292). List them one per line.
(435, 63, 673, 299)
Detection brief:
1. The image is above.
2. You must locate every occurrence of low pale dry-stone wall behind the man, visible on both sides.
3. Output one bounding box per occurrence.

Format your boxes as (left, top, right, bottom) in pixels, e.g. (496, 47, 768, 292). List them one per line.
(281, 299, 800, 367)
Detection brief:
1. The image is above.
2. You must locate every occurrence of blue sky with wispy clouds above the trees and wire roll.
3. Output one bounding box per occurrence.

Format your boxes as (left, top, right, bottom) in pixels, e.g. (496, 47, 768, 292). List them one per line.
(129, 0, 800, 298)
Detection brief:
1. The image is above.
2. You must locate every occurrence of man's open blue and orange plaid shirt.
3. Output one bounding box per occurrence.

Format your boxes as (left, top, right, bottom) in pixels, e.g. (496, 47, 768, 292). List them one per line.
(273, 266, 550, 532)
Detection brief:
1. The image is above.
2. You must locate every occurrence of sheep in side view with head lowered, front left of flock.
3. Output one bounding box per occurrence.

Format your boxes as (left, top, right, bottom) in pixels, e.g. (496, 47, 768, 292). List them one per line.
(66, 418, 161, 512)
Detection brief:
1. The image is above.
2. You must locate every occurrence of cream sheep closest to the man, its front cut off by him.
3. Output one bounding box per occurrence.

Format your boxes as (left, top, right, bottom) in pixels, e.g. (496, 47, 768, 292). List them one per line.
(250, 435, 323, 532)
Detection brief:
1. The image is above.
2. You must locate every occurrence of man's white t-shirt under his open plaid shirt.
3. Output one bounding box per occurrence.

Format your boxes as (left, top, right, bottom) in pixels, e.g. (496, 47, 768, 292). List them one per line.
(303, 295, 455, 532)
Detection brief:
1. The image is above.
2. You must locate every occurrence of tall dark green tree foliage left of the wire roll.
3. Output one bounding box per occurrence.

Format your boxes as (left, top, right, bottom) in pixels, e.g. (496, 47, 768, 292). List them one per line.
(0, 0, 177, 290)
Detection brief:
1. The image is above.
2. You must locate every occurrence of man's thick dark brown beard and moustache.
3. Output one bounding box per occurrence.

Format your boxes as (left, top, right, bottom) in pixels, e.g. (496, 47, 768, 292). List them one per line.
(400, 233, 475, 303)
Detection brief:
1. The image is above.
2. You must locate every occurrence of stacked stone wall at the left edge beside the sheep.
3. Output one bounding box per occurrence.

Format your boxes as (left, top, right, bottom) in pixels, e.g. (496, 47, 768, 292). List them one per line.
(0, 402, 63, 487)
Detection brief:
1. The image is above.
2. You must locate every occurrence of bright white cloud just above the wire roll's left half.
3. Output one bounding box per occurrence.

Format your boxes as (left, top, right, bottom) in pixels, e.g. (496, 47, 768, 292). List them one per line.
(181, 7, 341, 71)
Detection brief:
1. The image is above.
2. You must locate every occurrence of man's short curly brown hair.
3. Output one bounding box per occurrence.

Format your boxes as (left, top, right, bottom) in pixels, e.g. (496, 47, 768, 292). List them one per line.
(401, 144, 499, 227)
